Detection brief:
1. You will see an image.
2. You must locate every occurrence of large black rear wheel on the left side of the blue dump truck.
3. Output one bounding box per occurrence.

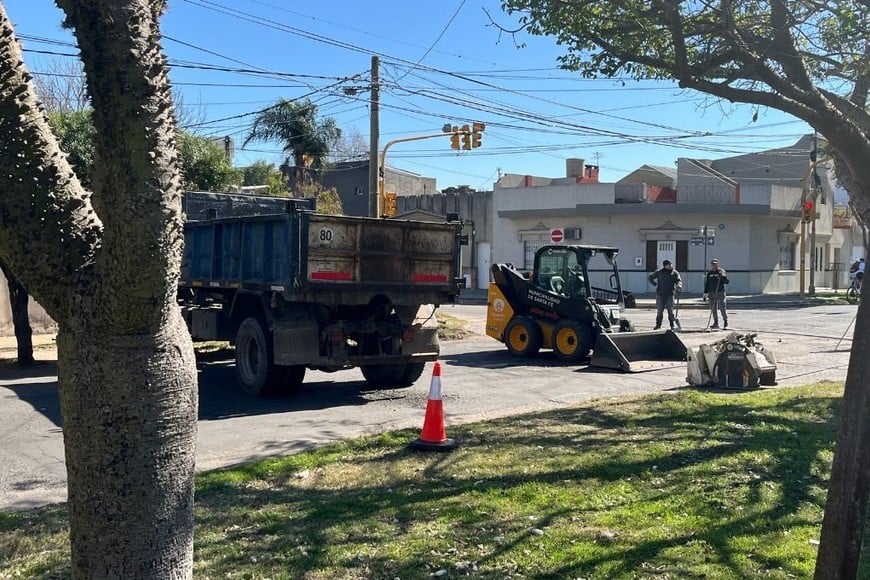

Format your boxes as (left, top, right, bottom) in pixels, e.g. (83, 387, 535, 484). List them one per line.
(236, 318, 284, 396)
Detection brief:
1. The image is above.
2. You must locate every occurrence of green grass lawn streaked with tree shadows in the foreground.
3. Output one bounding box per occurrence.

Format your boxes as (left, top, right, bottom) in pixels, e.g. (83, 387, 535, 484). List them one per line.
(0, 379, 864, 580)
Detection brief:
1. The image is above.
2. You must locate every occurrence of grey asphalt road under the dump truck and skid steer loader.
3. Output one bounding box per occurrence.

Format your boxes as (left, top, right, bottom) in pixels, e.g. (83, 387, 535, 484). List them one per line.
(0, 305, 856, 510)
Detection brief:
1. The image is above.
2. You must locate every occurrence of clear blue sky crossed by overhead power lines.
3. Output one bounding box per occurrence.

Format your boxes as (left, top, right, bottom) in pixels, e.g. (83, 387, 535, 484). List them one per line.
(4, 0, 811, 189)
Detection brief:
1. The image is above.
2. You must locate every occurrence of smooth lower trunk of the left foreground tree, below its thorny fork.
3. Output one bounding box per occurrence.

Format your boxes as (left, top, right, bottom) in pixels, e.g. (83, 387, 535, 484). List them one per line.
(58, 307, 197, 579)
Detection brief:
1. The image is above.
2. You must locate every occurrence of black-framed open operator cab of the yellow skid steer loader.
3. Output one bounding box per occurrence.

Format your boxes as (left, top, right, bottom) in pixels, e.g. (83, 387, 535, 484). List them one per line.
(531, 246, 623, 305)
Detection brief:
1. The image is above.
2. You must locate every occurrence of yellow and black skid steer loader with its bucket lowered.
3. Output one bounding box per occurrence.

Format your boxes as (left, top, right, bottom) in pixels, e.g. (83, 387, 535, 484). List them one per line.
(486, 245, 687, 372)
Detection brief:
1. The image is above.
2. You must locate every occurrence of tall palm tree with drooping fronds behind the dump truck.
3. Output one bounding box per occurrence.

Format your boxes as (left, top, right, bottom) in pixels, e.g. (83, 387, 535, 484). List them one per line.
(244, 99, 341, 176)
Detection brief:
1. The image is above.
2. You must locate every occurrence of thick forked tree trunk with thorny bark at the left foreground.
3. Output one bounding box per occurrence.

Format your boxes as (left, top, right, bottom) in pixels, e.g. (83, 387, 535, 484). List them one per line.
(0, 0, 197, 578)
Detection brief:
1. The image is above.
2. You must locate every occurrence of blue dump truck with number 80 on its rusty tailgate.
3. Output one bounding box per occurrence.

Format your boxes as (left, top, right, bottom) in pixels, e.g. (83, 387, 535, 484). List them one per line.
(178, 192, 465, 395)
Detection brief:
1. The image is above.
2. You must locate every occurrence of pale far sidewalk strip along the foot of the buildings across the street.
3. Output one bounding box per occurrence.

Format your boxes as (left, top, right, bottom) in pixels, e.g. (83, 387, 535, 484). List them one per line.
(457, 288, 846, 309)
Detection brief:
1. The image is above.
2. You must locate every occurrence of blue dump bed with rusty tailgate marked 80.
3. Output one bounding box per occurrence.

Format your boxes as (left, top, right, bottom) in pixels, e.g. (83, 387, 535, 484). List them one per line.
(180, 194, 464, 305)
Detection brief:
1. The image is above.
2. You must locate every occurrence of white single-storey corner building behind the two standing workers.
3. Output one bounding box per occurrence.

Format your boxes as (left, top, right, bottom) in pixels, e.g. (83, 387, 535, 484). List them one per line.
(492, 136, 851, 294)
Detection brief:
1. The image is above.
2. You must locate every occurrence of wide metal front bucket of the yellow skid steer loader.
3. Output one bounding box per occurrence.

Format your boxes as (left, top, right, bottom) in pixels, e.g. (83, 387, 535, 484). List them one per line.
(589, 330, 688, 373)
